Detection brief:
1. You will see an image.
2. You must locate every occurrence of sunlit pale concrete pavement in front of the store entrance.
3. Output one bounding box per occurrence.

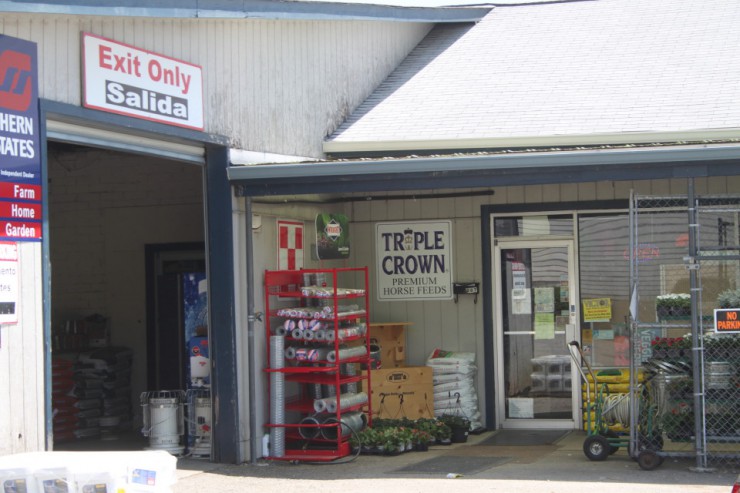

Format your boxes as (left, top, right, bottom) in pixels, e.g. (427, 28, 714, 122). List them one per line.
(173, 432, 737, 493)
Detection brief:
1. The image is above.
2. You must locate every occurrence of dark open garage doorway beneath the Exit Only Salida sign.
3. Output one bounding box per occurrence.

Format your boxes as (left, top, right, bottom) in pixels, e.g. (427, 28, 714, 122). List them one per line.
(47, 141, 205, 450)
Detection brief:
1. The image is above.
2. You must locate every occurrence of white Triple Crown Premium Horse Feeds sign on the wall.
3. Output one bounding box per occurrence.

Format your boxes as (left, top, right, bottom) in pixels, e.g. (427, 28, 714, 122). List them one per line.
(375, 221, 453, 301)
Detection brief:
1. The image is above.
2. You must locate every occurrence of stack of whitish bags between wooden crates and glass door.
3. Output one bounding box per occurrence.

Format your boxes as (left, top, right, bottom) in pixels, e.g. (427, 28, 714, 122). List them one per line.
(427, 349, 483, 431)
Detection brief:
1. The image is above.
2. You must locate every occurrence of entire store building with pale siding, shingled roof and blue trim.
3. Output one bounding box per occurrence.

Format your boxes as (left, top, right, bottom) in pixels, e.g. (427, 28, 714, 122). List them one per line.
(0, 0, 740, 462)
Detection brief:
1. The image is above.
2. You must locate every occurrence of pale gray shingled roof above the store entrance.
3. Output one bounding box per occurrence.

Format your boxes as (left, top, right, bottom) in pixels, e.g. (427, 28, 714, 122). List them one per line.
(325, 0, 740, 154)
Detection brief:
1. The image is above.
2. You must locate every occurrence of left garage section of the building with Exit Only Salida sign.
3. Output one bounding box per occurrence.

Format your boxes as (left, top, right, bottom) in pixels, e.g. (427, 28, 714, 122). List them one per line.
(0, 1, 488, 462)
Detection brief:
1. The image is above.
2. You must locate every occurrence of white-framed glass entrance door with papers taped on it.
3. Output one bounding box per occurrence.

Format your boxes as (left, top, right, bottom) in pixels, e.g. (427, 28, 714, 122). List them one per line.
(493, 240, 580, 429)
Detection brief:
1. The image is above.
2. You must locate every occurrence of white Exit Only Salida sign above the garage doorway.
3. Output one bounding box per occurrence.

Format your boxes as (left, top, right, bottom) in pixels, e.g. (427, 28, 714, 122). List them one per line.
(82, 33, 203, 130)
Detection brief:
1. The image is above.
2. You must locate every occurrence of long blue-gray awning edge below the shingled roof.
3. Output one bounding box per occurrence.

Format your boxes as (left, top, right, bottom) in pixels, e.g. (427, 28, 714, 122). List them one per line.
(228, 143, 740, 196)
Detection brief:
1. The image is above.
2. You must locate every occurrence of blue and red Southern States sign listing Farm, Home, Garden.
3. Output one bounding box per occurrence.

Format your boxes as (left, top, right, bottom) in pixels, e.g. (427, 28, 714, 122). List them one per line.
(0, 35, 42, 241)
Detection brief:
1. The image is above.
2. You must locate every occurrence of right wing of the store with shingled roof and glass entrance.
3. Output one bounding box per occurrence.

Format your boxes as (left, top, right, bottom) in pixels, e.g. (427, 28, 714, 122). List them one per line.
(229, 2, 738, 466)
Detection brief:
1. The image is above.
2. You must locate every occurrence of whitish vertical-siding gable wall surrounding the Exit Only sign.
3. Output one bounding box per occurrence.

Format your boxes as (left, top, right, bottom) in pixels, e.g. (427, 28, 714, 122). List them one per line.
(0, 14, 431, 157)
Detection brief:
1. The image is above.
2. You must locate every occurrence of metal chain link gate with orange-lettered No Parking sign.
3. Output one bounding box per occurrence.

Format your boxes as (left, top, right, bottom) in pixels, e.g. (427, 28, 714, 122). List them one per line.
(629, 179, 740, 471)
